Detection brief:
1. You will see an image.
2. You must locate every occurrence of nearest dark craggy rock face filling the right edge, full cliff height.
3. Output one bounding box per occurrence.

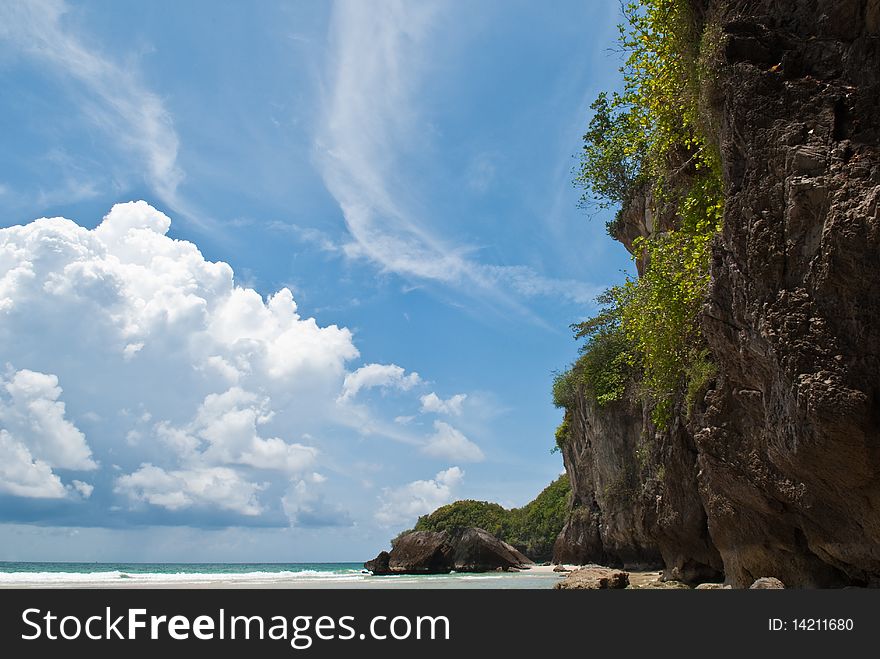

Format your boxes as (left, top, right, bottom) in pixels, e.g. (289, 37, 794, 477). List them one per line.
(696, 0, 880, 586)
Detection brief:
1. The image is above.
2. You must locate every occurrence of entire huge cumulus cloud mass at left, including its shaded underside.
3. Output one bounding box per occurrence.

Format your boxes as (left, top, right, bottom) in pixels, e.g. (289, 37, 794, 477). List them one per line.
(0, 201, 366, 516)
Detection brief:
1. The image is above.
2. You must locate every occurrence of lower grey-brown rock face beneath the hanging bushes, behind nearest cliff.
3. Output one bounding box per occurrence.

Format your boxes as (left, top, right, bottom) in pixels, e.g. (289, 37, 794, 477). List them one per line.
(553, 386, 722, 582)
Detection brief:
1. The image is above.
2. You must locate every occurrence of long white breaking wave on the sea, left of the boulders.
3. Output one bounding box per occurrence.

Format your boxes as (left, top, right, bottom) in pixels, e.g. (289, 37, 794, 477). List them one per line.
(0, 570, 367, 585)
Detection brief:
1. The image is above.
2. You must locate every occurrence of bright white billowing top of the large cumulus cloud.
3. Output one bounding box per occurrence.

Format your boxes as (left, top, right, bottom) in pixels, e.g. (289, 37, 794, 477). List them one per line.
(0, 201, 358, 381)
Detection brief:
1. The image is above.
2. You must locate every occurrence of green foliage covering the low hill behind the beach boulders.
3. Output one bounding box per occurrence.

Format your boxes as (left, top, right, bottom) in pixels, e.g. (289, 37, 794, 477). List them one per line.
(414, 475, 571, 561)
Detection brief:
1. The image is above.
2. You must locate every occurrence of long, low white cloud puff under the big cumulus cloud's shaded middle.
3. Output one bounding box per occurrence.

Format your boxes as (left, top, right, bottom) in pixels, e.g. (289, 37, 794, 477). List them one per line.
(114, 463, 262, 516)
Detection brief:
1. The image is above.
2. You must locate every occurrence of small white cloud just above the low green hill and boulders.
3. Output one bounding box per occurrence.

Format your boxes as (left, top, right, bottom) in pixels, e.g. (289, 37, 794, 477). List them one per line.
(375, 467, 464, 526)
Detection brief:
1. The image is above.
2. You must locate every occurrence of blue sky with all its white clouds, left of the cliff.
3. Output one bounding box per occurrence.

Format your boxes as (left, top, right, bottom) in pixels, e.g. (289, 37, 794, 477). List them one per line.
(0, 0, 630, 562)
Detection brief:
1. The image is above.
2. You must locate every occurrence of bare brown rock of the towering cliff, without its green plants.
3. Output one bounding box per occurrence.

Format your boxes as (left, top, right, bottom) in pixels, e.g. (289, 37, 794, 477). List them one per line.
(554, 0, 880, 587)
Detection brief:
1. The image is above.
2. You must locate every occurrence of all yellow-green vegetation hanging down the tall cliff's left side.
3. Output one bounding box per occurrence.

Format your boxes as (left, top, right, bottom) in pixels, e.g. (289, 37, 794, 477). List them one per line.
(553, 0, 723, 428)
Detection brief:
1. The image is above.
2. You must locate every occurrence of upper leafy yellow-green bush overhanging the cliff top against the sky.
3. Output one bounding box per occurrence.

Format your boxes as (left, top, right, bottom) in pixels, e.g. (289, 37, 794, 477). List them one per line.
(575, 0, 718, 209)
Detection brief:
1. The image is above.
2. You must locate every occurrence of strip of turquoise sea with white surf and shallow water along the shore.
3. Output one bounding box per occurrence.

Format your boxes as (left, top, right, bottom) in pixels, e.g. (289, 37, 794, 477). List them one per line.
(0, 562, 559, 589)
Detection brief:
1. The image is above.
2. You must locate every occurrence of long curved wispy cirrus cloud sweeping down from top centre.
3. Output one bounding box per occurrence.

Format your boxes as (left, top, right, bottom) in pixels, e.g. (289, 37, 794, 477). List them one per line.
(315, 0, 599, 311)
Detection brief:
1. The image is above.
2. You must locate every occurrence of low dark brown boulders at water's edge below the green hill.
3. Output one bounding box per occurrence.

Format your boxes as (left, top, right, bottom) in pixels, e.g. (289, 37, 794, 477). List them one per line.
(364, 527, 534, 575)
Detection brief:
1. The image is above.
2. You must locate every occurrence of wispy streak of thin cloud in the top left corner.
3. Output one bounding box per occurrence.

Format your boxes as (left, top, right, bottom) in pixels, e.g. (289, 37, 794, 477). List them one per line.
(0, 0, 184, 211)
